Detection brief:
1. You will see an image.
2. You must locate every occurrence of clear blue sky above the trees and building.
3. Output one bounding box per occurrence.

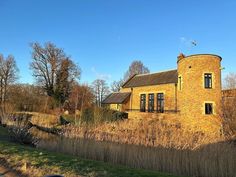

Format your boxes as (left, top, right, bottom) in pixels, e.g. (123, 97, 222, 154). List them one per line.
(0, 0, 236, 84)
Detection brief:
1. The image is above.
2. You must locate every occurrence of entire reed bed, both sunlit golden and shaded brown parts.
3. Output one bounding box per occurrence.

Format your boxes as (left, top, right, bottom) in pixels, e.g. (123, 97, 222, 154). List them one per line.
(6, 112, 236, 177)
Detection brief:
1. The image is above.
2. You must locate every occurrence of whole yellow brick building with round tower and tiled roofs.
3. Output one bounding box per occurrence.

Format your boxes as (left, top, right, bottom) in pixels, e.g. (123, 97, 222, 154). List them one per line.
(103, 54, 222, 117)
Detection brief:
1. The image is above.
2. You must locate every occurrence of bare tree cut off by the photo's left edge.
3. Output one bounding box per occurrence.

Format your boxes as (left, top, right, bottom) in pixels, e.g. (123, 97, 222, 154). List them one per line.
(0, 54, 18, 112)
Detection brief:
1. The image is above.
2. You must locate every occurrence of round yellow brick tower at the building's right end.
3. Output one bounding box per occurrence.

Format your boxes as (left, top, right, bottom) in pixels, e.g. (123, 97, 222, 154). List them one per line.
(177, 54, 222, 118)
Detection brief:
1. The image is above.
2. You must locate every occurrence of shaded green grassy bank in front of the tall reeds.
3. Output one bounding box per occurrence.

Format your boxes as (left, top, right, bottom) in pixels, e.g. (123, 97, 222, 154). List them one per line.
(0, 142, 179, 177)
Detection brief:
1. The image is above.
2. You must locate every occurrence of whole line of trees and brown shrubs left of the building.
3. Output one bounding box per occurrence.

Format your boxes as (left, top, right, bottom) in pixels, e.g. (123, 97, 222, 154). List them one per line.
(0, 42, 150, 113)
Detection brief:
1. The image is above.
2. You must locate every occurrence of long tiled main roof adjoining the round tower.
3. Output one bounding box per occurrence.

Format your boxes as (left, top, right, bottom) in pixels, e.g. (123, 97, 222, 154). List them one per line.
(122, 70, 178, 88)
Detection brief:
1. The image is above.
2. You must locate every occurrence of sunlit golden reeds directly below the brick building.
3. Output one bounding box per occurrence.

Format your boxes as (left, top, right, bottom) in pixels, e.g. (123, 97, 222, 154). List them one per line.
(64, 115, 223, 149)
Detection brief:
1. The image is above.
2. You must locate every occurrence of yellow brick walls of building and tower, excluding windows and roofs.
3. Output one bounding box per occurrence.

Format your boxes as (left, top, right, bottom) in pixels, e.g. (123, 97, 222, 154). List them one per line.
(108, 54, 222, 119)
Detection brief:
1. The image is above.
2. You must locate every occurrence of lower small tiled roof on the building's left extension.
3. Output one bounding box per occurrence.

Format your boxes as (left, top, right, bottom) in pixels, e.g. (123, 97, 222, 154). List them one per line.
(102, 92, 131, 104)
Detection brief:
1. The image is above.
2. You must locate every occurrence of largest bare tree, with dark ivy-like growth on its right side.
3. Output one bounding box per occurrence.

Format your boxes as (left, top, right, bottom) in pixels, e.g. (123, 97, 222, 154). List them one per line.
(30, 42, 81, 105)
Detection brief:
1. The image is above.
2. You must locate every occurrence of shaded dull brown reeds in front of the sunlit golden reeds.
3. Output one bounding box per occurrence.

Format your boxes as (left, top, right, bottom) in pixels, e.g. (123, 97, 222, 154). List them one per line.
(33, 129, 236, 177)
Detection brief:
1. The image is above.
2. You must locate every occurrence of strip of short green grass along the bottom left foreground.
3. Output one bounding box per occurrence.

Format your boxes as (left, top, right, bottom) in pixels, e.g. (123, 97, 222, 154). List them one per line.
(0, 126, 184, 177)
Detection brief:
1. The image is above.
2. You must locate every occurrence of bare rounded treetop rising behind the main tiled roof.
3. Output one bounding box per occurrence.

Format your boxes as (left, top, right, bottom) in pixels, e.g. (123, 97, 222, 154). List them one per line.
(124, 60, 150, 81)
